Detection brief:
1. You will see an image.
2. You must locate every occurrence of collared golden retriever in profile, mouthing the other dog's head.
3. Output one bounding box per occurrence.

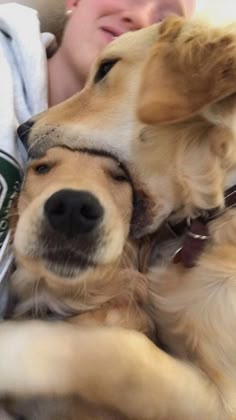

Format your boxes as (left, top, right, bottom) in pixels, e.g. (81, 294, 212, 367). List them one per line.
(0, 17, 236, 420)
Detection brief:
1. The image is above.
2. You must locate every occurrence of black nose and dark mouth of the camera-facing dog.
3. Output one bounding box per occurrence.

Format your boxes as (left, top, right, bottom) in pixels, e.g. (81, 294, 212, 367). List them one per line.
(37, 189, 104, 277)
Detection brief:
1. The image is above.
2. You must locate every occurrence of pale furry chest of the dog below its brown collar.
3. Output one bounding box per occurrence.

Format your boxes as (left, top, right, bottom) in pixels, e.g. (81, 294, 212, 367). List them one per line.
(149, 215, 236, 388)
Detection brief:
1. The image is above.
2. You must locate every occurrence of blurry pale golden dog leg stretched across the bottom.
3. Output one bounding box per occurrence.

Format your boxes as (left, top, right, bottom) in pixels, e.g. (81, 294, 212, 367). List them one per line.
(0, 321, 223, 420)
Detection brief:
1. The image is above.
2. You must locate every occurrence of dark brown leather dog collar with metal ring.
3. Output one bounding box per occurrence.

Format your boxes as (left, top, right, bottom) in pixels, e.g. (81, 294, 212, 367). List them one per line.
(168, 185, 236, 268)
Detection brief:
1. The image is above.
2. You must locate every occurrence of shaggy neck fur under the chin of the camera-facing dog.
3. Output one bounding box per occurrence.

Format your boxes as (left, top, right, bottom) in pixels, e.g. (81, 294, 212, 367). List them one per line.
(10, 265, 123, 319)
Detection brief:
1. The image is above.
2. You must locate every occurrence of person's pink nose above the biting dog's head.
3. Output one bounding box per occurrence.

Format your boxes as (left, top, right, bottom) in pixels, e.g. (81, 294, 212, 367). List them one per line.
(122, 5, 155, 31)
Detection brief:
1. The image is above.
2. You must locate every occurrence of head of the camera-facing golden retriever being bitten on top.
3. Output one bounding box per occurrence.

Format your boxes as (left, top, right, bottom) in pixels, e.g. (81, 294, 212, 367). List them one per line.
(13, 147, 154, 281)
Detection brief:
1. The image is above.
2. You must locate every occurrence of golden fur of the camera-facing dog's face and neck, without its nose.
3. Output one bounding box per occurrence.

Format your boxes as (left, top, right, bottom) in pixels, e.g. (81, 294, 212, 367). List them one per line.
(11, 148, 153, 332)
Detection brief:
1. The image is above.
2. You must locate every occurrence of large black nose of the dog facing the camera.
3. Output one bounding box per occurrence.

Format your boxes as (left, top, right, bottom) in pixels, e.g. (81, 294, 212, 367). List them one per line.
(44, 190, 104, 238)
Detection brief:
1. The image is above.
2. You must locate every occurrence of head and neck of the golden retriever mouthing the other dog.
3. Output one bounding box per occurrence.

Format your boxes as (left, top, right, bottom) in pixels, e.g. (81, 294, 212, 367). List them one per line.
(19, 17, 236, 231)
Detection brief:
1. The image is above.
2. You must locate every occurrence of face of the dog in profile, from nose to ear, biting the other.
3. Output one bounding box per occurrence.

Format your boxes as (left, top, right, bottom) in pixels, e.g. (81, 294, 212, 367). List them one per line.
(18, 25, 158, 159)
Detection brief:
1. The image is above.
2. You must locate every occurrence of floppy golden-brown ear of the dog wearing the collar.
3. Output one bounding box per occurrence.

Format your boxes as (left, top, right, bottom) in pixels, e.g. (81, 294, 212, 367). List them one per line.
(138, 16, 236, 124)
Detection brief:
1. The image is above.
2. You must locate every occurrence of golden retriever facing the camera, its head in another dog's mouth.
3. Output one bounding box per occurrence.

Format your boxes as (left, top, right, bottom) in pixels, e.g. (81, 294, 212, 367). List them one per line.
(3, 147, 157, 420)
